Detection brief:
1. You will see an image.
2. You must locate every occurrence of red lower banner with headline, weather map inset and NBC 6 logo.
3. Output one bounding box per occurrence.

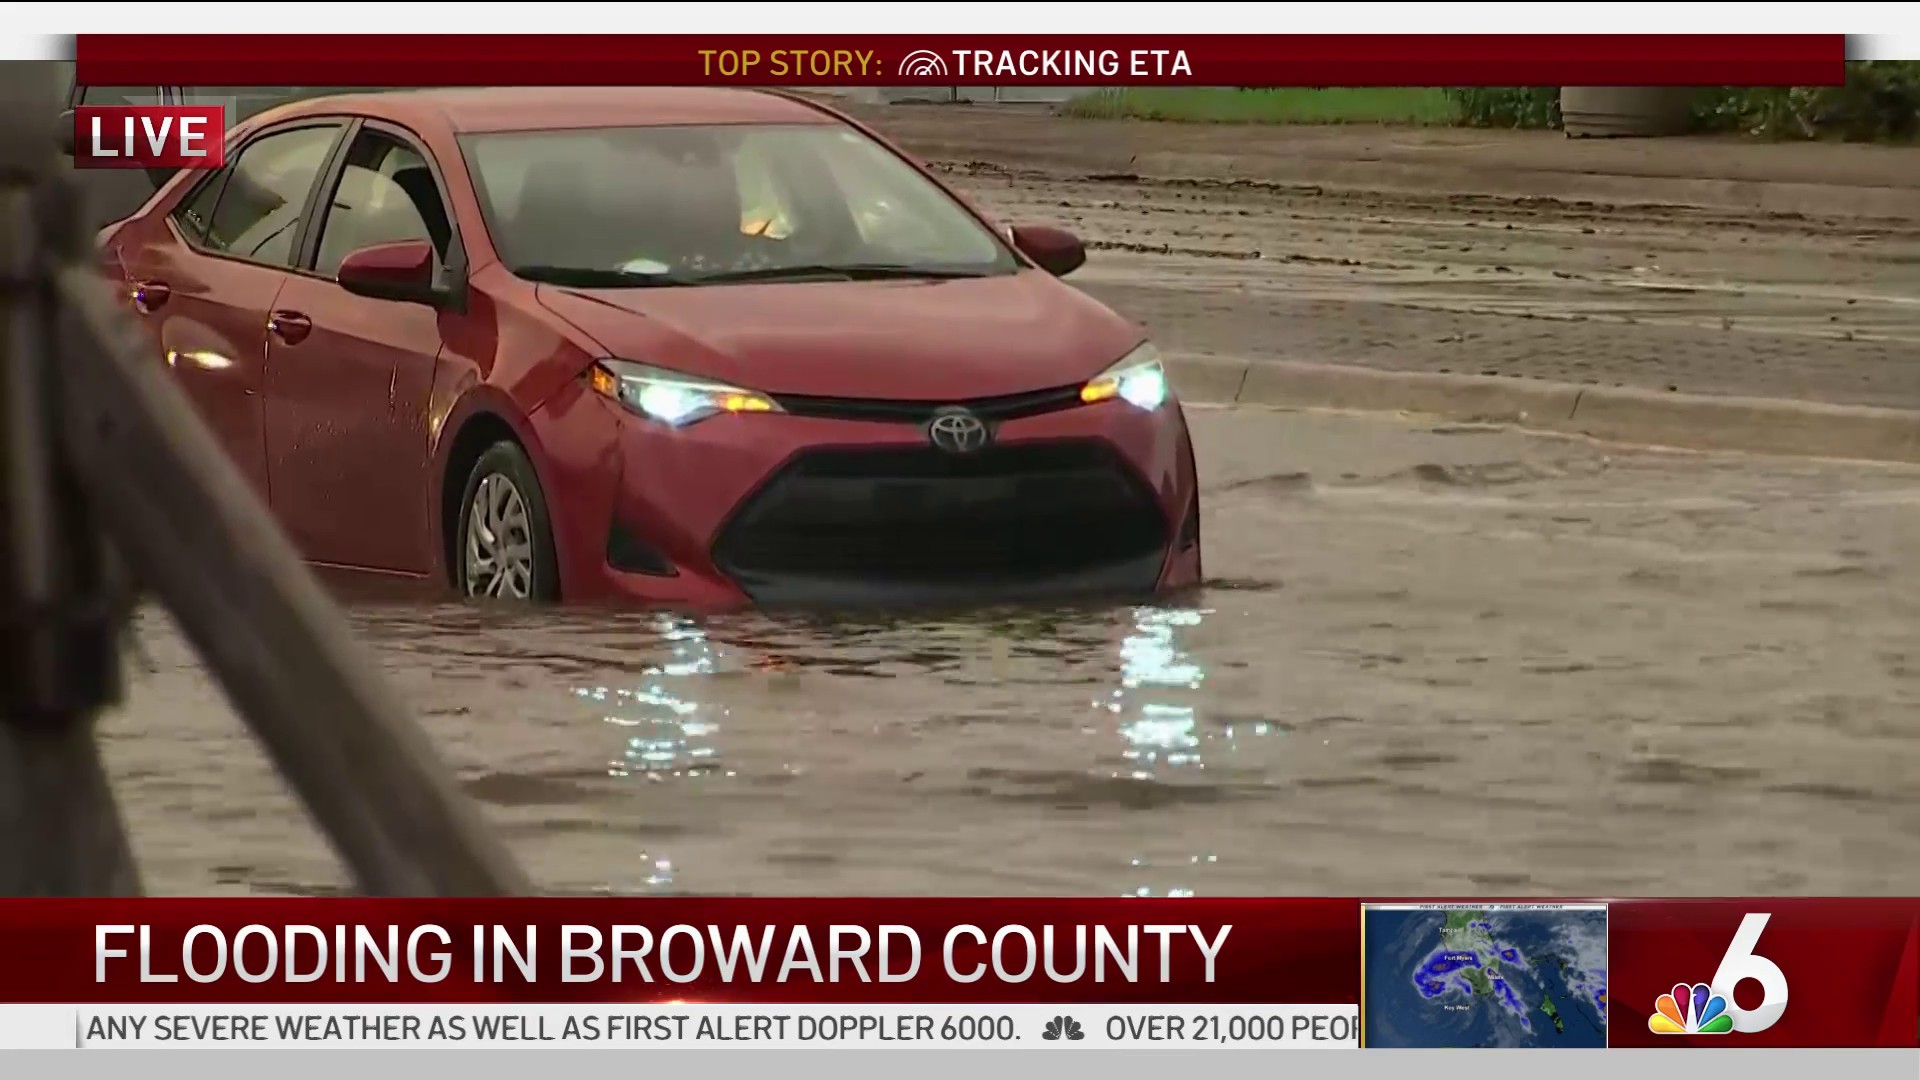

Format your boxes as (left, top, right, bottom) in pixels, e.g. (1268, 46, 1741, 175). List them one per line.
(0, 897, 1920, 1047)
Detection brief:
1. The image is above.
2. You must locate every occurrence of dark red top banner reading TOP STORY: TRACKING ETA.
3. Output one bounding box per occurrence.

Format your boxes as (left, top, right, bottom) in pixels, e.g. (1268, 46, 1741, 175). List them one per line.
(75, 35, 1847, 86)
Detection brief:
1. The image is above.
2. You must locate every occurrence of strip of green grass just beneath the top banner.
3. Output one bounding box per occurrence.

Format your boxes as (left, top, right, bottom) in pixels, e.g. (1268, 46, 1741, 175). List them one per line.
(1066, 86, 1459, 125)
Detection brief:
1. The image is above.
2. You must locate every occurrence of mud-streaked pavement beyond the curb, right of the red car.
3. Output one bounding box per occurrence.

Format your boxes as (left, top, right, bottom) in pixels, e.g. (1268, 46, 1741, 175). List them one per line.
(939, 158, 1920, 407)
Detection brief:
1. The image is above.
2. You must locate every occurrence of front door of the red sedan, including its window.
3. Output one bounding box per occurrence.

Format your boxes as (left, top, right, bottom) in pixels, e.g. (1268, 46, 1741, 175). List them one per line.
(267, 121, 465, 573)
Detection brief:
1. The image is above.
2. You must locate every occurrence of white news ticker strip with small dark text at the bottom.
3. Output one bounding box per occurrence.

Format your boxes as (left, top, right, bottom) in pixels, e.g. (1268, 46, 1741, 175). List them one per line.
(0, 1003, 1359, 1049)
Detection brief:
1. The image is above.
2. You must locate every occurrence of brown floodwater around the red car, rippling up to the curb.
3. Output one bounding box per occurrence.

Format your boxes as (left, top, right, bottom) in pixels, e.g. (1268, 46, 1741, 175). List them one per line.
(104, 401, 1920, 896)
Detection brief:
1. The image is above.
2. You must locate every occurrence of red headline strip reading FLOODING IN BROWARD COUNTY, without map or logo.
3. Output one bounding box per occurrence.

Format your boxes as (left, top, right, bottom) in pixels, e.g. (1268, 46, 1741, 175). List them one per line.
(0, 899, 1359, 1005)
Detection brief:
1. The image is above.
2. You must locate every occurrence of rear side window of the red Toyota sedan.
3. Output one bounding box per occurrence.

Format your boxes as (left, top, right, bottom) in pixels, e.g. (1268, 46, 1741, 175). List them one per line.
(204, 125, 340, 267)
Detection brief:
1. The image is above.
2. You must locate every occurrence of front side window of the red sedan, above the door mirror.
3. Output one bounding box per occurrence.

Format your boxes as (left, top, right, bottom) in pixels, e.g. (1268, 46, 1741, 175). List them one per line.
(313, 131, 453, 277)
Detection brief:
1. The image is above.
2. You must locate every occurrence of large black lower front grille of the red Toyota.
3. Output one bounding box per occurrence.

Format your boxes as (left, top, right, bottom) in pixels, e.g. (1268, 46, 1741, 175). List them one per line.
(714, 442, 1167, 600)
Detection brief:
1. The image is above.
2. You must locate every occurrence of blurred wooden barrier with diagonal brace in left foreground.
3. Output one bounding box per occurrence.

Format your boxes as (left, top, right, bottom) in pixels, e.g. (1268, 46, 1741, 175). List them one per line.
(0, 63, 530, 896)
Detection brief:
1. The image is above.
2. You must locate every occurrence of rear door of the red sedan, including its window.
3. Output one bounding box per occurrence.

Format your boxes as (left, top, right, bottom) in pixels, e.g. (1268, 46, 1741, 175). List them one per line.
(104, 121, 344, 498)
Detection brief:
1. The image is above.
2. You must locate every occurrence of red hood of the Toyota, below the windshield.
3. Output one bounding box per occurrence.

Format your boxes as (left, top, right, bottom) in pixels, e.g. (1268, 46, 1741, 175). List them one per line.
(538, 271, 1142, 402)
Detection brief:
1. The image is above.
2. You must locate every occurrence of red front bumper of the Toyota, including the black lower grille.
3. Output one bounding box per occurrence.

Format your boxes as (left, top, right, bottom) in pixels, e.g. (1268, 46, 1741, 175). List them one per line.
(557, 384, 1200, 607)
